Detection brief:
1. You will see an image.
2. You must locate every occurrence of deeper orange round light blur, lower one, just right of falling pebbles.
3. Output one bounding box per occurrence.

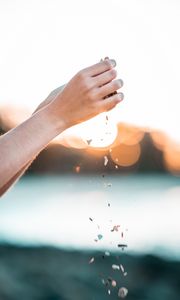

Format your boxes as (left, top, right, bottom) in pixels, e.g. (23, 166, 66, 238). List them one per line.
(110, 144, 141, 167)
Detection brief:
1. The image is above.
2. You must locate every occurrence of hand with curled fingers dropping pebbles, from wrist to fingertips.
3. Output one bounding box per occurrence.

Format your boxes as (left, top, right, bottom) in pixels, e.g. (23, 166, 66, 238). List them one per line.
(49, 59, 123, 128)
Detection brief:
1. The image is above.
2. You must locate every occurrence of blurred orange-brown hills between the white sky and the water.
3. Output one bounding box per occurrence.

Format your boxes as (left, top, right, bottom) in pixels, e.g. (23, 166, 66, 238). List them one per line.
(0, 108, 180, 175)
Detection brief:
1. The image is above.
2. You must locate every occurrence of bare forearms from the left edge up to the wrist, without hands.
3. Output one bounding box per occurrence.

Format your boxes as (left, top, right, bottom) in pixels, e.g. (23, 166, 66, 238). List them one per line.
(0, 106, 65, 194)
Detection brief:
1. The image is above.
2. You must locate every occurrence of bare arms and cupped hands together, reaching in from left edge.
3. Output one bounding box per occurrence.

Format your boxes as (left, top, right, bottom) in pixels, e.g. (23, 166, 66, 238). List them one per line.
(0, 59, 123, 196)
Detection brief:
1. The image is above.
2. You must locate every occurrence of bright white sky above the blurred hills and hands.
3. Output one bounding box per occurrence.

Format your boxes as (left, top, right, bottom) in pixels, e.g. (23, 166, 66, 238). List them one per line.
(0, 0, 180, 141)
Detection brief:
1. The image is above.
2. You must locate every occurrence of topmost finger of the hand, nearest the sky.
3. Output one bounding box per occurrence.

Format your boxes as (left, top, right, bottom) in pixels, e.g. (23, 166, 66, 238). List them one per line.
(84, 59, 116, 77)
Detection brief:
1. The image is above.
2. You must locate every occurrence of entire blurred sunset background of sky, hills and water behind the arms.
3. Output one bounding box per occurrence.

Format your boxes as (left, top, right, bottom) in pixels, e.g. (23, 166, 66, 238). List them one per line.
(0, 0, 180, 300)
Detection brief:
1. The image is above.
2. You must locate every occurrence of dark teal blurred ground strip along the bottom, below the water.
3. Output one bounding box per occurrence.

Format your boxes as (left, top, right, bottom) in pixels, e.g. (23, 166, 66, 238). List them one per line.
(0, 245, 180, 300)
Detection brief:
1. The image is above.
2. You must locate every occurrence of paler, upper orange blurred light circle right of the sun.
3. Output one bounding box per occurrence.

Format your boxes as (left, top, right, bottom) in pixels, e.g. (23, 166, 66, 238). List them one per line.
(114, 123, 144, 146)
